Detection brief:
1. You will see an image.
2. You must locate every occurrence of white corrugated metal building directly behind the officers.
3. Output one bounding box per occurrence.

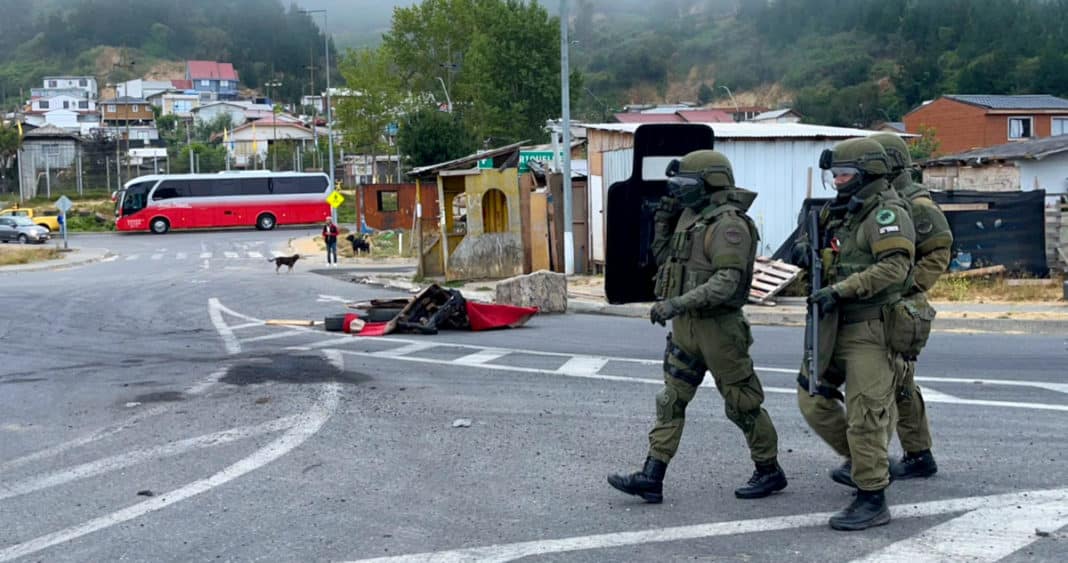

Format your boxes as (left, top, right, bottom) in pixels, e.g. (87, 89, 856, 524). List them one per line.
(584, 122, 876, 264)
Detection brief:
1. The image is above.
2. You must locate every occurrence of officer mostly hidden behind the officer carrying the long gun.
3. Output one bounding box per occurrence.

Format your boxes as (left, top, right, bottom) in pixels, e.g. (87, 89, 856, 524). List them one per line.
(870, 132, 953, 479)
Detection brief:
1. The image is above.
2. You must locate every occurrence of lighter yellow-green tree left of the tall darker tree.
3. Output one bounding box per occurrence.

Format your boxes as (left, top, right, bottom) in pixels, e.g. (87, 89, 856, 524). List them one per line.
(335, 46, 405, 181)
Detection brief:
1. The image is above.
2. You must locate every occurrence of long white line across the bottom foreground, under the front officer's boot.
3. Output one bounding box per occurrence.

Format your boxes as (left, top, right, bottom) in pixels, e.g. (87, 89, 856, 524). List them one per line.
(343, 489, 1068, 563)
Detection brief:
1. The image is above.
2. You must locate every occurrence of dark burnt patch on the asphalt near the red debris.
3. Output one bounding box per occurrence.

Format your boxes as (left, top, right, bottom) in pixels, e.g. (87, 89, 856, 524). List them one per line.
(219, 355, 371, 386)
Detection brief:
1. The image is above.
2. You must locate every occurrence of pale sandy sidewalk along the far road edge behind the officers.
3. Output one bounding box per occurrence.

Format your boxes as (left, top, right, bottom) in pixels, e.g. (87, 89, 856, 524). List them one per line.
(343, 272, 1068, 334)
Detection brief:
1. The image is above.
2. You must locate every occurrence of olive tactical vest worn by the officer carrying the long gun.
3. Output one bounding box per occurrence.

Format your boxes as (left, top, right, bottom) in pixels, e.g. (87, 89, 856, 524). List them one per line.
(821, 184, 912, 314)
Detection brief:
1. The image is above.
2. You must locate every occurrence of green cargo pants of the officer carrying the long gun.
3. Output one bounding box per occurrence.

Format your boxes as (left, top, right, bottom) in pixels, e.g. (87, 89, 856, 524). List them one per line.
(798, 319, 902, 490)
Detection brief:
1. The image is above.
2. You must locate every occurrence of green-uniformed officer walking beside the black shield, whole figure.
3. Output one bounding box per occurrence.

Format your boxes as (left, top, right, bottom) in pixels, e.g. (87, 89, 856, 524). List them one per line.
(608, 151, 786, 502)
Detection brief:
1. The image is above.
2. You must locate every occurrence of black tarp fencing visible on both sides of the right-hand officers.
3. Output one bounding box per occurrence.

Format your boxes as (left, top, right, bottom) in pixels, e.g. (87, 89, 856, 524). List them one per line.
(772, 190, 1049, 276)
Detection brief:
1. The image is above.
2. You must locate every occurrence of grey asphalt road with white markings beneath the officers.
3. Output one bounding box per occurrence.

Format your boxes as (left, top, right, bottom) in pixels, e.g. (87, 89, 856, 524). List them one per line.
(0, 230, 1068, 562)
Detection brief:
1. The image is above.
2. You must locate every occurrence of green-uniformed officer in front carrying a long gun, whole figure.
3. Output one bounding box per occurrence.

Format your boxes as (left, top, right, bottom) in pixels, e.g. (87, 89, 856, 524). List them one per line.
(798, 139, 915, 530)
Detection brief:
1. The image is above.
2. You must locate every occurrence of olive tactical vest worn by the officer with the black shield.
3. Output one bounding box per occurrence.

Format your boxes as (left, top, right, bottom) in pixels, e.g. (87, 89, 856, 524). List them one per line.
(655, 198, 759, 311)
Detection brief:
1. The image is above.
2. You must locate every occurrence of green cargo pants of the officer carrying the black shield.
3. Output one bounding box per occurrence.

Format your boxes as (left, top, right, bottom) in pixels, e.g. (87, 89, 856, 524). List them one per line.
(648, 311, 779, 464)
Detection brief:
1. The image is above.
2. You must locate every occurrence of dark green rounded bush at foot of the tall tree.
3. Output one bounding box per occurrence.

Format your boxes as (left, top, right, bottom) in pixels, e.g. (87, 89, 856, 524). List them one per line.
(397, 108, 478, 168)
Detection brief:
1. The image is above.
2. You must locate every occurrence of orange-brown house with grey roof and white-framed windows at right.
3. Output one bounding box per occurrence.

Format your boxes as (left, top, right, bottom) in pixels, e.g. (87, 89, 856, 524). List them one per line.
(905, 94, 1068, 154)
